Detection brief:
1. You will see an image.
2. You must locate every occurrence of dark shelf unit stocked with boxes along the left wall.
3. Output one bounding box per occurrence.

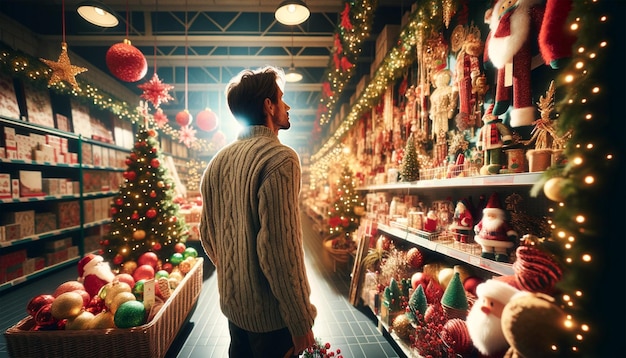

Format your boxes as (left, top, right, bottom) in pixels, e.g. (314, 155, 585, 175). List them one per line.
(0, 117, 129, 293)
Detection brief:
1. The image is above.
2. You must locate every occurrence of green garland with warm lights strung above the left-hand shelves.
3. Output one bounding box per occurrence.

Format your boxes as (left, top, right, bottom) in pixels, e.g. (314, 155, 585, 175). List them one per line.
(0, 43, 216, 153)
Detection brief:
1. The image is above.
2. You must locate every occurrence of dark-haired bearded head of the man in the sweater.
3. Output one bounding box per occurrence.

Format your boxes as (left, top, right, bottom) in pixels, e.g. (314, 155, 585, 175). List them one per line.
(226, 66, 290, 132)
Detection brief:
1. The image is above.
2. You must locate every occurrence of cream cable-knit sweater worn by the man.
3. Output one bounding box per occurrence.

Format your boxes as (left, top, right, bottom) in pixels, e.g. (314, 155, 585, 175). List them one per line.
(200, 126, 317, 336)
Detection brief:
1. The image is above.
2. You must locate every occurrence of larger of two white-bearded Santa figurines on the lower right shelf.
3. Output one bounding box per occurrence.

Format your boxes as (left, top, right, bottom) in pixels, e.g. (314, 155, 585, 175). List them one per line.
(474, 193, 517, 262)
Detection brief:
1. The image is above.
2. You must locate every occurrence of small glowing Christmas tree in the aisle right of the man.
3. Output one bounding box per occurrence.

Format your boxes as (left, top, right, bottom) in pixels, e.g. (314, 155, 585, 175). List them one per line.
(328, 165, 363, 246)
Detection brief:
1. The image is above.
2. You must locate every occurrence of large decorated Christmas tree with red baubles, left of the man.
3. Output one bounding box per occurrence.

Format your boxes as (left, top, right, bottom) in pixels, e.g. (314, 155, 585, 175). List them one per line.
(101, 127, 189, 268)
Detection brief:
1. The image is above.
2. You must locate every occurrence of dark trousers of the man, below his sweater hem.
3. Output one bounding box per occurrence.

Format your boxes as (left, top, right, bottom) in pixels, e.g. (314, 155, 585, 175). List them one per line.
(228, 321, 298, 358)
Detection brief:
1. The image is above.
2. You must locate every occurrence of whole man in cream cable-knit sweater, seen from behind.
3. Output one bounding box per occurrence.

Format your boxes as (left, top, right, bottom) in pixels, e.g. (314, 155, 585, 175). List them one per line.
(200, 67, 317, 357)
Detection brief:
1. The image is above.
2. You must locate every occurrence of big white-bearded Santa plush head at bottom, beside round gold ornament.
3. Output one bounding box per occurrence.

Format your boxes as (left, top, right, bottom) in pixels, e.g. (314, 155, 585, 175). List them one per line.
(465, 279, 519, 357)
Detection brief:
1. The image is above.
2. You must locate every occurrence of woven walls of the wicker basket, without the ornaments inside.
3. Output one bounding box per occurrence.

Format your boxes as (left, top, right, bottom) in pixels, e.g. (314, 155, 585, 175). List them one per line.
(4, 257, 203, 358)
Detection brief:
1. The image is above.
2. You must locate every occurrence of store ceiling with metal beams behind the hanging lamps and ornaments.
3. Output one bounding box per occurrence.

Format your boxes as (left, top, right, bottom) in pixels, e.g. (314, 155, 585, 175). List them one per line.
(0, 0, 415, 150)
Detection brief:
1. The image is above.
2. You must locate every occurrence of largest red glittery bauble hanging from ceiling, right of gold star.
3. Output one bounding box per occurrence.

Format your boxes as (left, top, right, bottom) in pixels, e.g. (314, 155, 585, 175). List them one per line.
(106, 39, 148, 82)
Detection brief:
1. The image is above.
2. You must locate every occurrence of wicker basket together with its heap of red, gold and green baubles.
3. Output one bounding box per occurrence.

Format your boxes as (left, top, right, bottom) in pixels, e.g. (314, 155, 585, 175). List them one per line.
(5, 248, 203, 358)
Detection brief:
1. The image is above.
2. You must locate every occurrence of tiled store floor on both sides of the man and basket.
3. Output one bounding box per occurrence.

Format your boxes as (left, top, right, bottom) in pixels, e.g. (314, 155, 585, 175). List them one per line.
(0, 215, 404, 358)
